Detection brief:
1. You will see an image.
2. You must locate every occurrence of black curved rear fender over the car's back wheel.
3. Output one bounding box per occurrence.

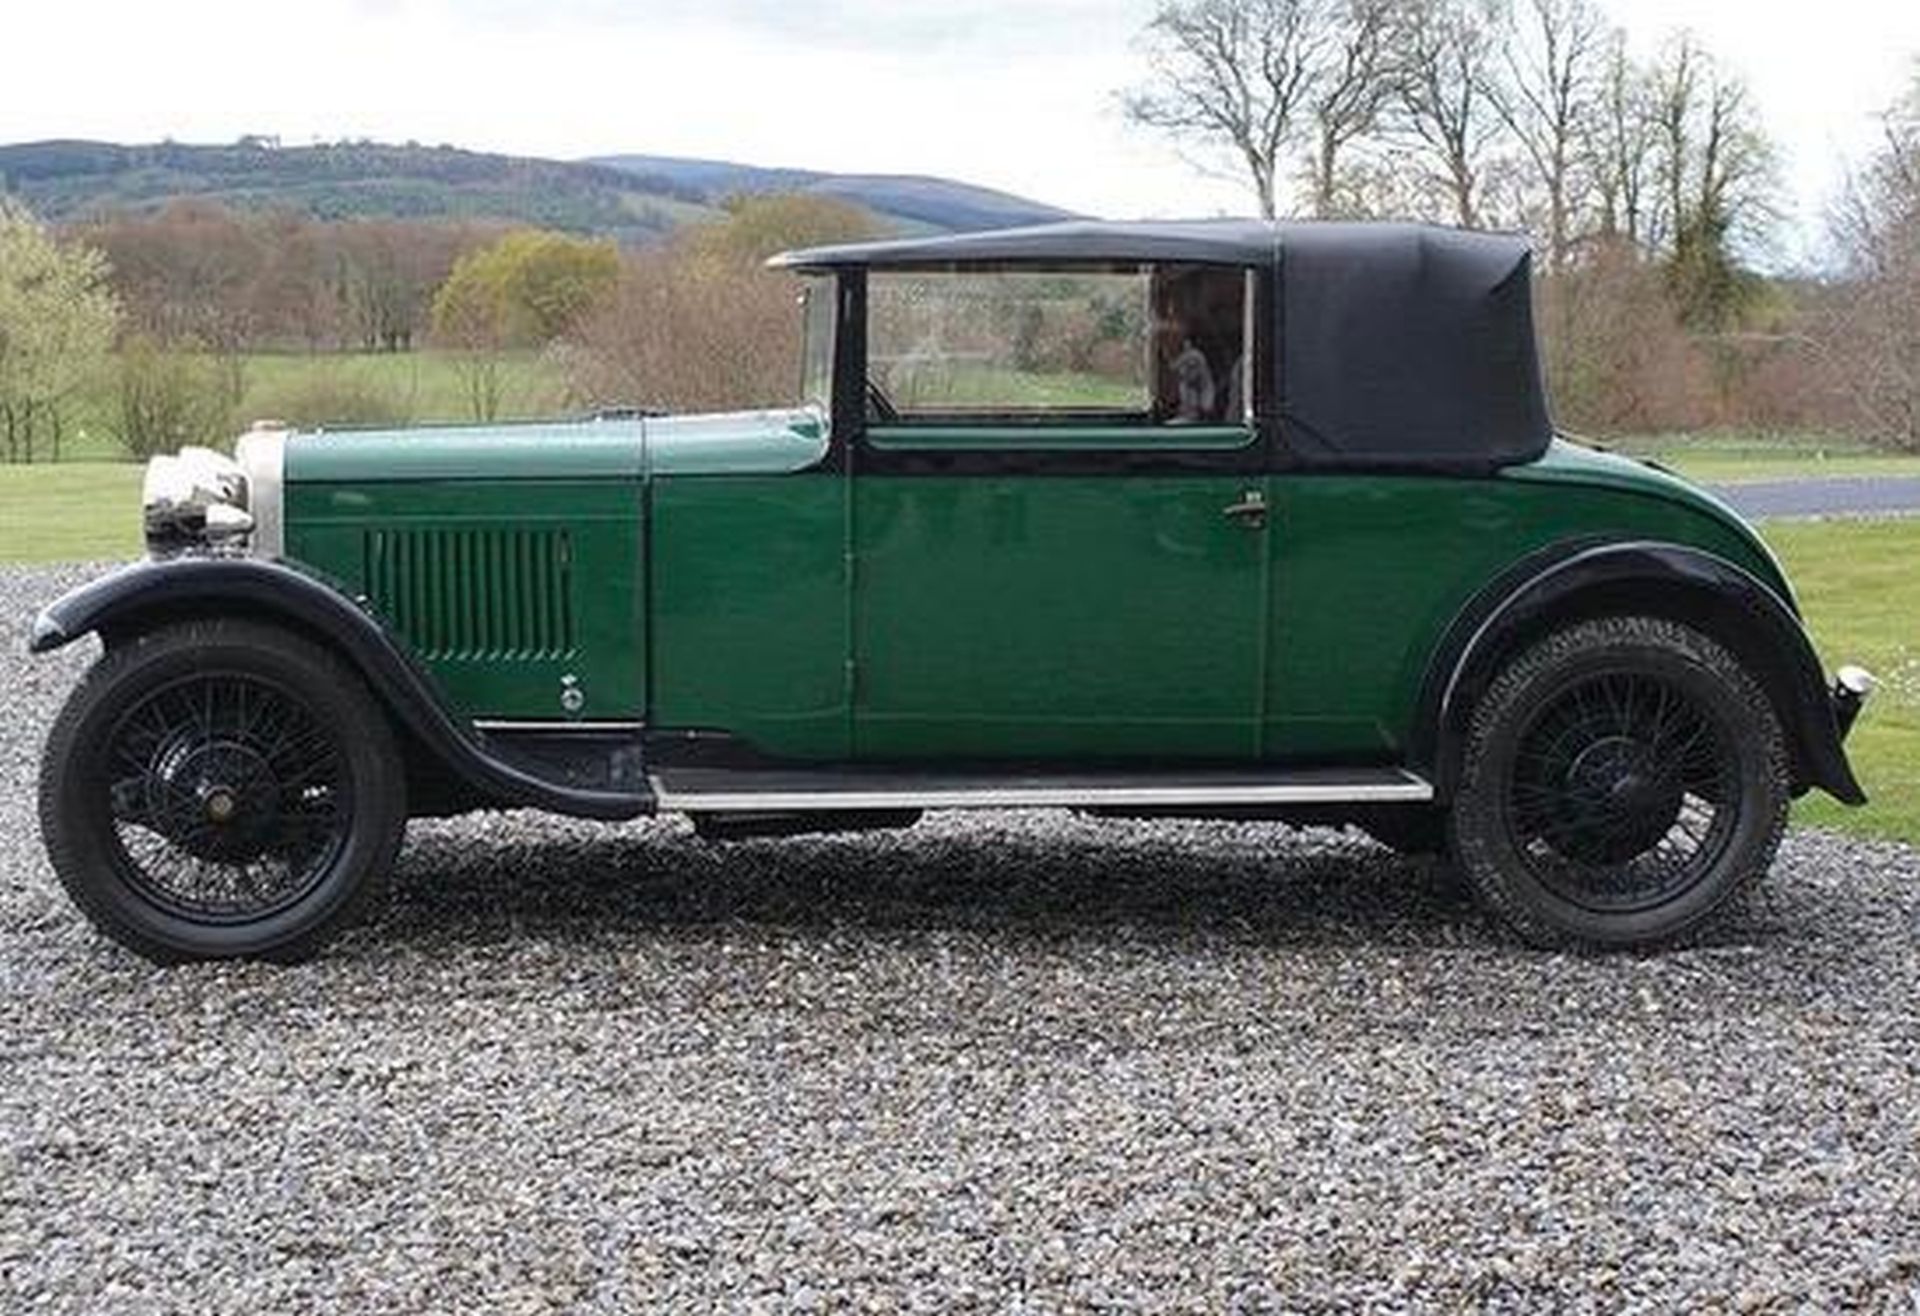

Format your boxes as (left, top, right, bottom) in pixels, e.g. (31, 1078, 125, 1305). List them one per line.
(1413, 542, 1866, 805)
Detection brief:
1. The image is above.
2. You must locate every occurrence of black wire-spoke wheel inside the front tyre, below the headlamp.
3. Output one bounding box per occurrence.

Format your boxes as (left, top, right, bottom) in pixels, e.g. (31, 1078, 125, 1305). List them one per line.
(108, 672, 353, 922)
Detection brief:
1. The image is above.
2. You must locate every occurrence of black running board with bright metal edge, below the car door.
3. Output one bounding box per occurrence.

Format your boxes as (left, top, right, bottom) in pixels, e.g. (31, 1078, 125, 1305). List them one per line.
(651, 768, 1434, 813)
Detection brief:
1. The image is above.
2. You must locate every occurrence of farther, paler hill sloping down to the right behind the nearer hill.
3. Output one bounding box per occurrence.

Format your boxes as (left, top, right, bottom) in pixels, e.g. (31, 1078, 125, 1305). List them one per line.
(588, 156, 1073, 232)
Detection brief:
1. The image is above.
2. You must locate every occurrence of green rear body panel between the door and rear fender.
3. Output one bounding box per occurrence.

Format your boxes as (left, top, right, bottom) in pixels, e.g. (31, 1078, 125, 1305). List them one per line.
(1265, 467, 1772, 761)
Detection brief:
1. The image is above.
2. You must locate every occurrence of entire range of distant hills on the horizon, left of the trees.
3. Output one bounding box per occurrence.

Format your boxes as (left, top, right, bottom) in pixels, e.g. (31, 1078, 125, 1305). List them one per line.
(0, 138, 1066, 242)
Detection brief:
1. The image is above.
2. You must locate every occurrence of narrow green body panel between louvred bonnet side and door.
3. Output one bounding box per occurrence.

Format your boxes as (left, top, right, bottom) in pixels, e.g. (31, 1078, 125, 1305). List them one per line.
(649, 475, 849, 759)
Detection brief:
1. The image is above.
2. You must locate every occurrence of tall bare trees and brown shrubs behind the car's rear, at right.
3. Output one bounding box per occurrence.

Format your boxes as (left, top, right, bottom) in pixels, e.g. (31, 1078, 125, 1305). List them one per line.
(1125, 0, 1920, 448)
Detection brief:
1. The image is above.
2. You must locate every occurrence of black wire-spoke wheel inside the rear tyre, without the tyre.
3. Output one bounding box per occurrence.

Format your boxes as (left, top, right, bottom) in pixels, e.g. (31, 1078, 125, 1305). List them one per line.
(1507, 670, 1740, 913)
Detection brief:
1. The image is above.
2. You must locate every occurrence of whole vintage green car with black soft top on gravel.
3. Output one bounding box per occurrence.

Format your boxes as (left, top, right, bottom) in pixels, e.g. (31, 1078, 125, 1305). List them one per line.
(33, 221, 1872, 959)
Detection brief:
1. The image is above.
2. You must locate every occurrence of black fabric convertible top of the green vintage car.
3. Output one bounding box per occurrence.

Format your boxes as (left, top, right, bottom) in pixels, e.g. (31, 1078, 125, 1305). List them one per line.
(772, 219, 1553, 469)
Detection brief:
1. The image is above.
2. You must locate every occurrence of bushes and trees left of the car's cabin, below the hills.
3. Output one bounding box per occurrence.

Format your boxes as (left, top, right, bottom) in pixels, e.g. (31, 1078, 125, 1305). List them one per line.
(0, 196, 877, 461)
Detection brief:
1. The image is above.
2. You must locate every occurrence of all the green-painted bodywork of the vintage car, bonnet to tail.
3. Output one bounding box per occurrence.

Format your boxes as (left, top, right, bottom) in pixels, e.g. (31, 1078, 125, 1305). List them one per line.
(274, 411, 1812, 761)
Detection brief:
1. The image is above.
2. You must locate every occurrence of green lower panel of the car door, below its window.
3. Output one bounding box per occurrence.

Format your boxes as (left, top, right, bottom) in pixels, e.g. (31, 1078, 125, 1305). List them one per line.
(854, 475, 1265, 759)
